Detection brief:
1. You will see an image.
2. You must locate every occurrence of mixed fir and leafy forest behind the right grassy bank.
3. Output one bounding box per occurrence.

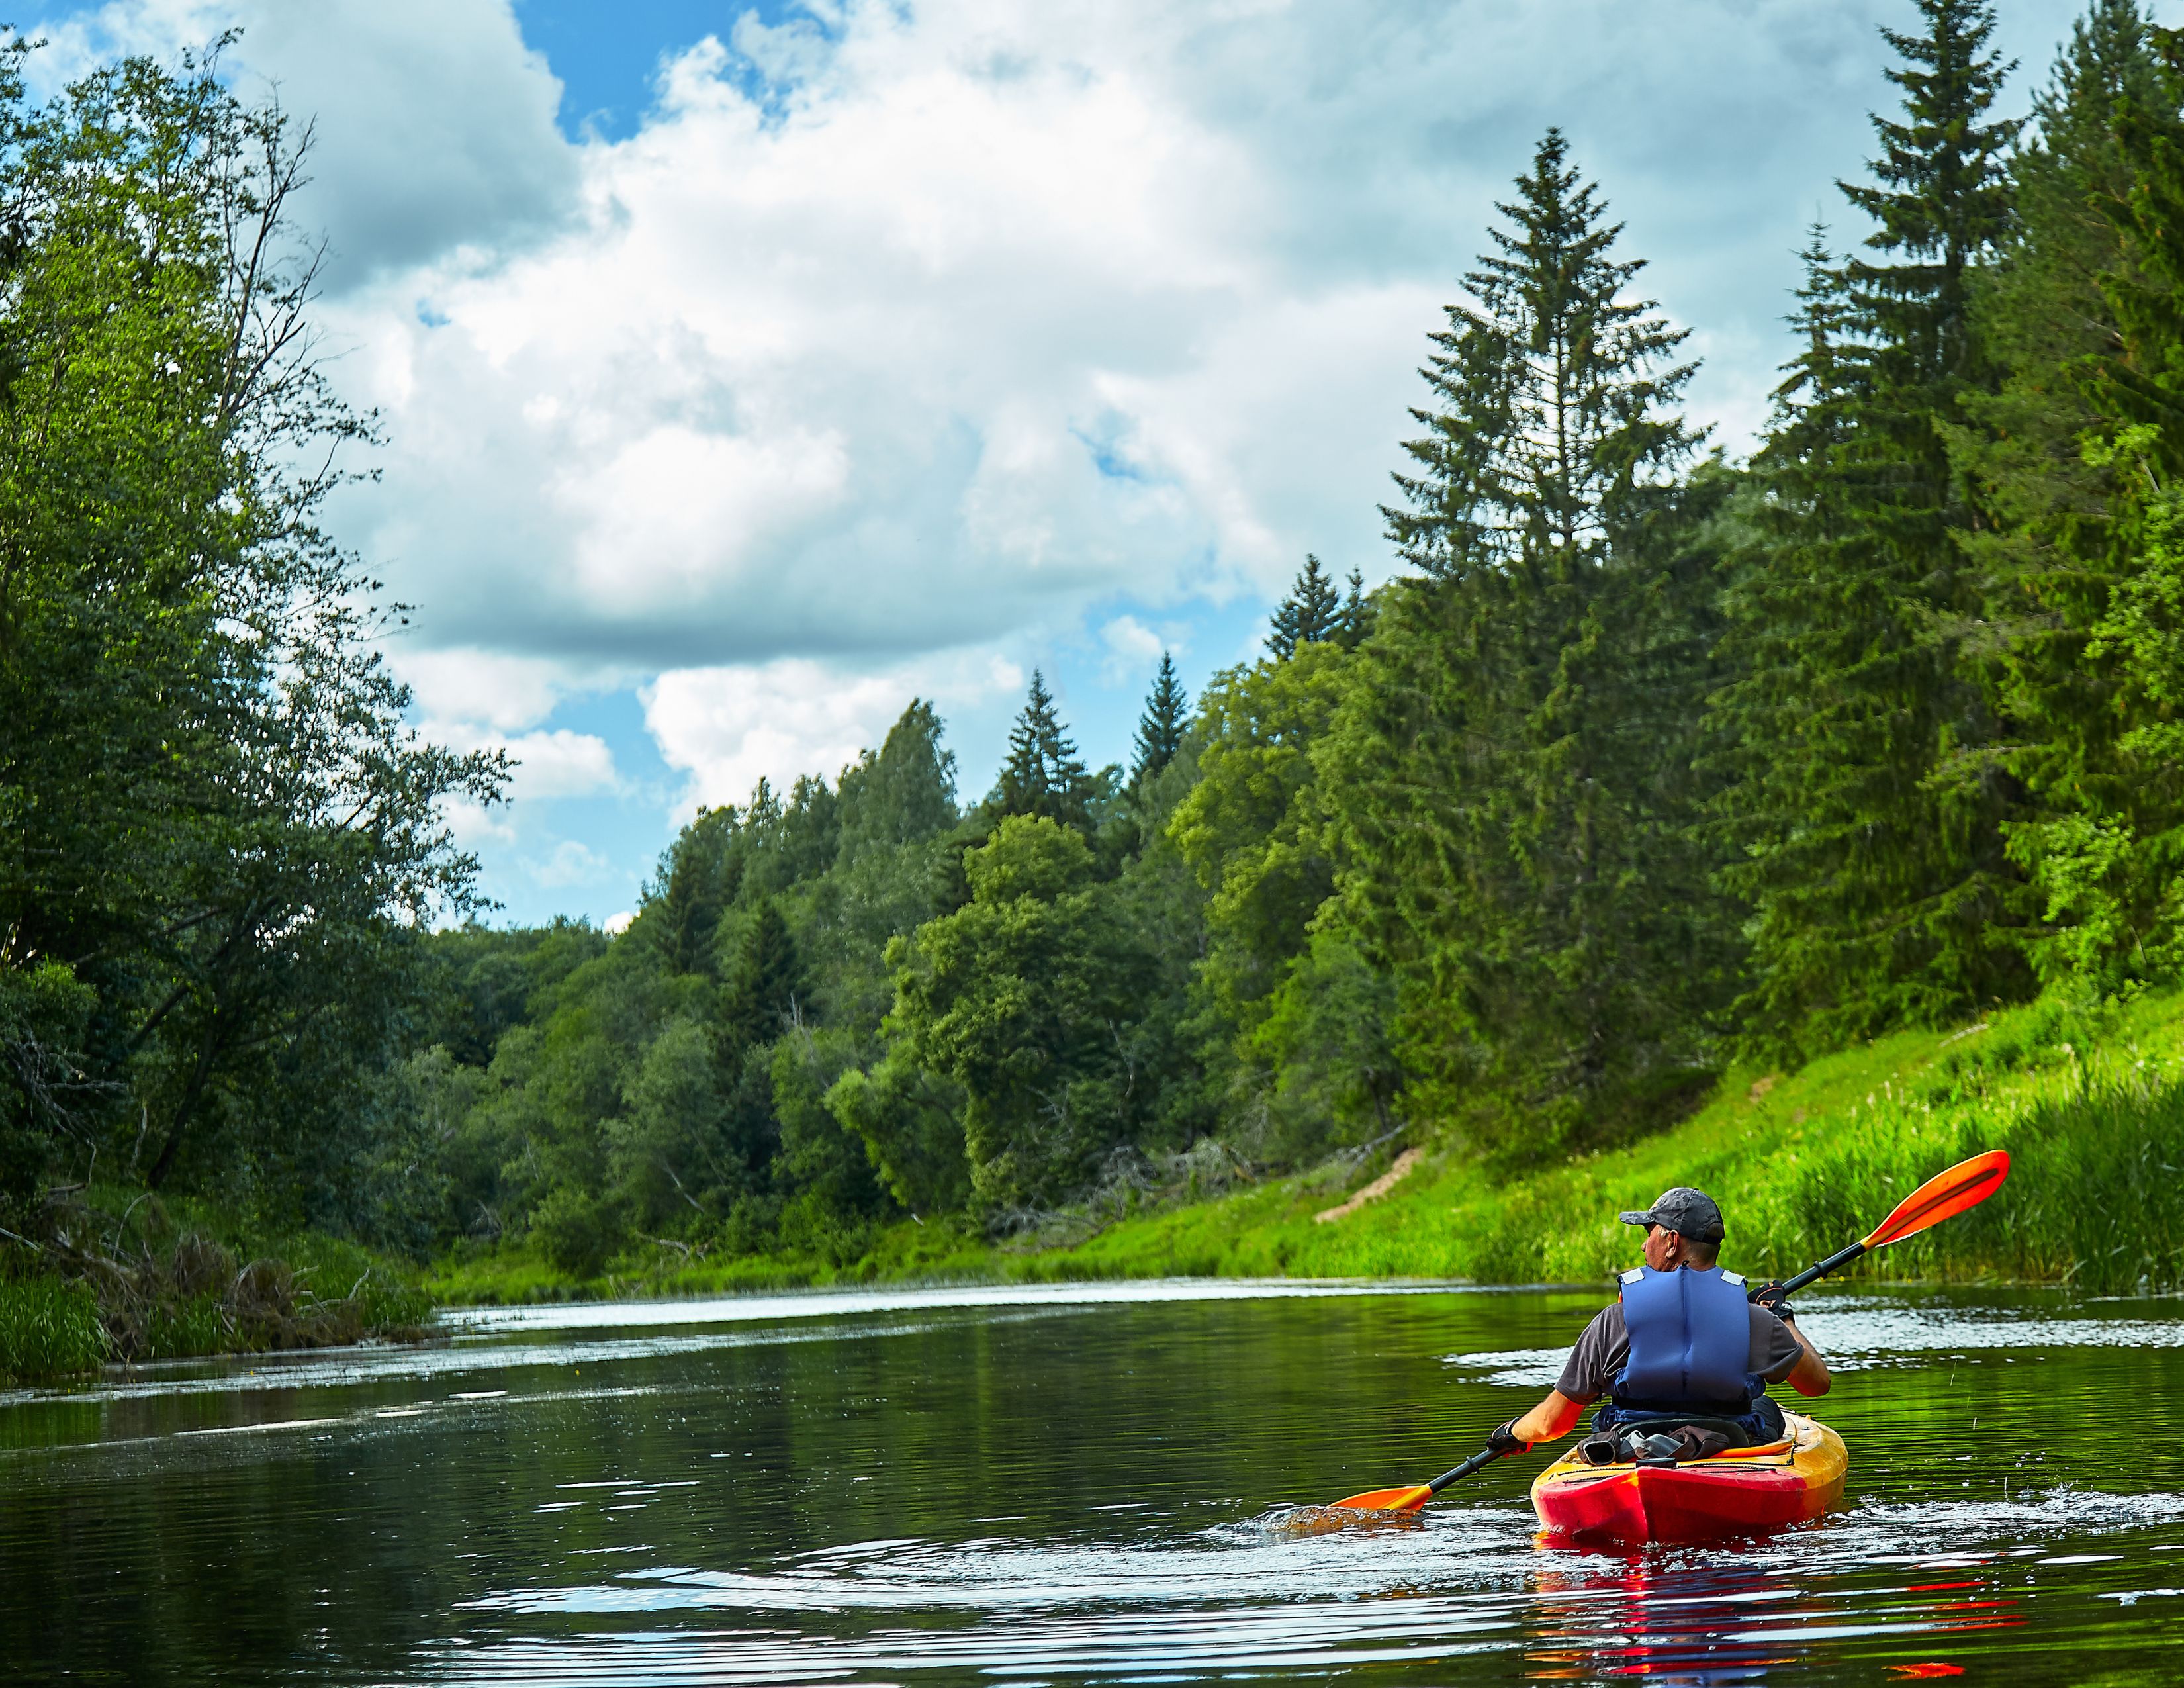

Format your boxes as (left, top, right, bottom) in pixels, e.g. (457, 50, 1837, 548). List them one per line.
(13, 0, 2184, 1276)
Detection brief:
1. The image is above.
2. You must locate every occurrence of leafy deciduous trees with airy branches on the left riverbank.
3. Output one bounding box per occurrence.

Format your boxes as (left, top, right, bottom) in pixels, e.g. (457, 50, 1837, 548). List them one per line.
(0, 42, 502, 1229)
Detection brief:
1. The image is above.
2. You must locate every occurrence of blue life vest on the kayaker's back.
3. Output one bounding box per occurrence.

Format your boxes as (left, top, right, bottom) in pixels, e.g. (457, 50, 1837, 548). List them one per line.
(1610, 1266, 1767, 1417)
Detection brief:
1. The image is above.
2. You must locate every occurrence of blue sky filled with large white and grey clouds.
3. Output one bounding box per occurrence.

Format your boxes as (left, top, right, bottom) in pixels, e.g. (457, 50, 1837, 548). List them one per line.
(37, 0, 2105, 921)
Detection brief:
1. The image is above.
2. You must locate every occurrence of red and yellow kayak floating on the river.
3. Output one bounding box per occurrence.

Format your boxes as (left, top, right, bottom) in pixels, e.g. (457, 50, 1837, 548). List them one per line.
(1531, 1413, 1850, 1542)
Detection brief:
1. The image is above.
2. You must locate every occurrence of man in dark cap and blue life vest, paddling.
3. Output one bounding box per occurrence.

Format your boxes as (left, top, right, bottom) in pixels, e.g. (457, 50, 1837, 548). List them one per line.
(1490, 1186, 1830, 1452)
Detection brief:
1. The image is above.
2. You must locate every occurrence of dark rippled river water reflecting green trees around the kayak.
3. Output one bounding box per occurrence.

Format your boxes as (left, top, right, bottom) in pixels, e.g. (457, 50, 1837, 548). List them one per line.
(0, 1282, 2184, 1688)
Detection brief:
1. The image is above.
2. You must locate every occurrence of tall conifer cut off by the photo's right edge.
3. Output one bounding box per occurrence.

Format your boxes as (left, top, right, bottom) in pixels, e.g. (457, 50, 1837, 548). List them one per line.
(1952, 0, 2184, 989)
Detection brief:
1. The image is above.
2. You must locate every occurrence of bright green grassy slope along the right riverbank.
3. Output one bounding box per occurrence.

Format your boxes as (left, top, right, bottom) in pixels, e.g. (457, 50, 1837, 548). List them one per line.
(430, 994, 2184, 1301)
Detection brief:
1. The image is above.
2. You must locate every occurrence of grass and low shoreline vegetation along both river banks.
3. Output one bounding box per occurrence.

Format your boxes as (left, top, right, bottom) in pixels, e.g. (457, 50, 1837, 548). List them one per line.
(0, 974, 2184, 1380)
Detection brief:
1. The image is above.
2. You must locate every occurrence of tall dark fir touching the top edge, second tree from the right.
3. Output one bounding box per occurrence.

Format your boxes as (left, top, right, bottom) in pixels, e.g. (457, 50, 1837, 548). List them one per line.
(1717, 0, 2029, 1053)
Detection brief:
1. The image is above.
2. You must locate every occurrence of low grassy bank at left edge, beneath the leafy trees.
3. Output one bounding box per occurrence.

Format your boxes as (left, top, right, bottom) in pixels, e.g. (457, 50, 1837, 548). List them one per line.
(0, 1186, 432, 1382)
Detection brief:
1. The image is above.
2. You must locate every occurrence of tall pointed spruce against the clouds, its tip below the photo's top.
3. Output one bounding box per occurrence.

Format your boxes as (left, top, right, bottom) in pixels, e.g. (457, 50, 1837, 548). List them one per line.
(1312, 129, 1730, 1153)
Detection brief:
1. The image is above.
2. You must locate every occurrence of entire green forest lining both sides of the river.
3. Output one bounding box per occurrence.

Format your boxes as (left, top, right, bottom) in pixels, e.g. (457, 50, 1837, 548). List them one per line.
(13, 0, 2184, 1336)
